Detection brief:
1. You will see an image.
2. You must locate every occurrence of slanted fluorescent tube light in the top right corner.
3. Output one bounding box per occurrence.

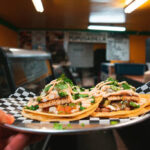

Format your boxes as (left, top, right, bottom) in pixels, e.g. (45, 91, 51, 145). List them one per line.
(124, 0, 148, 13)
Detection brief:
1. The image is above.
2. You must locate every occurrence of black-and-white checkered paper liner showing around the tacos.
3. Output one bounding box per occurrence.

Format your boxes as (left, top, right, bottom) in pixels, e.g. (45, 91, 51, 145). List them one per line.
(0, 82, 150, 125)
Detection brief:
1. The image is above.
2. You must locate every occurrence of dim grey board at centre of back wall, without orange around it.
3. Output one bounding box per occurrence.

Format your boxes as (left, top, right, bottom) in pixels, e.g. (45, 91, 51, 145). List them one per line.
(68, 43, 93, 68)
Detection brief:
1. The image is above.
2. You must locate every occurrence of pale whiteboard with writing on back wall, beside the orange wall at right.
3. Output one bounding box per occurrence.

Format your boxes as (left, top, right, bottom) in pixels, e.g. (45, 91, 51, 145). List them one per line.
(106, 37, 129, 61)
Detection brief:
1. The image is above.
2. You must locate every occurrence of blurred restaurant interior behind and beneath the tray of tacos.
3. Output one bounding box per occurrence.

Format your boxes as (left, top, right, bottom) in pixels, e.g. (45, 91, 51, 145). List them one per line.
(0, 0, 150, 150)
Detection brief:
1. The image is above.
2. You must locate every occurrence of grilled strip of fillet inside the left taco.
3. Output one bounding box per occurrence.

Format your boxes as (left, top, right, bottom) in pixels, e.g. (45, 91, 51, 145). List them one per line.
(38, 97, 71, 108)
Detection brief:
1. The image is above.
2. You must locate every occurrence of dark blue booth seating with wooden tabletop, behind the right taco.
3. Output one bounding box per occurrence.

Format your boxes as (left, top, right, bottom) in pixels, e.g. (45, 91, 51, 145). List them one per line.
(101, 63, 147, 87)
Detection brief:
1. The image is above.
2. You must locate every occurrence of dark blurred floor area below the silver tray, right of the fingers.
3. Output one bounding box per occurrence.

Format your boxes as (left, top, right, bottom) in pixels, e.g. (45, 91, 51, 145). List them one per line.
(31, 120, 150, 150)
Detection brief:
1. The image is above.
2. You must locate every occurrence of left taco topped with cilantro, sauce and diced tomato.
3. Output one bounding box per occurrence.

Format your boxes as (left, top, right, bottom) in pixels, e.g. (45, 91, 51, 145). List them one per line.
(22, 75, 102, 121)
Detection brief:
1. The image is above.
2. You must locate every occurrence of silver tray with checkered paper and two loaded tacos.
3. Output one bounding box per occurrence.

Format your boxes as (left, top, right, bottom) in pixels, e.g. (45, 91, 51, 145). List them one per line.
(0, 75, 150, 134)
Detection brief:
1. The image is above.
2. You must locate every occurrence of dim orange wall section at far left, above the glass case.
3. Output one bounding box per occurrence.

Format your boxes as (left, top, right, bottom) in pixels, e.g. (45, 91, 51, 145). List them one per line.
(0, 25, 18, 47)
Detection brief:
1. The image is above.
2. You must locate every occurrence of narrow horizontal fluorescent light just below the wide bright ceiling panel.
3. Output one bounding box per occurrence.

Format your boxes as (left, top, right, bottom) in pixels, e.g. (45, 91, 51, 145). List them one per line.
(88, 25, 126, 32)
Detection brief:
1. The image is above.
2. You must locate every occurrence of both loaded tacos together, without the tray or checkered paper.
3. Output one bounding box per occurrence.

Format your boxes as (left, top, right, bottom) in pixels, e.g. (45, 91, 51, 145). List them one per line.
(22, 74, 150, 121)
